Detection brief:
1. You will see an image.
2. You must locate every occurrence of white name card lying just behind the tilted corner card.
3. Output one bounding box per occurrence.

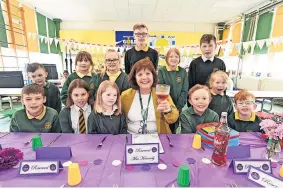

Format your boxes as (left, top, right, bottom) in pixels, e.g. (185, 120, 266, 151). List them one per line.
(233, 159, 272, 174)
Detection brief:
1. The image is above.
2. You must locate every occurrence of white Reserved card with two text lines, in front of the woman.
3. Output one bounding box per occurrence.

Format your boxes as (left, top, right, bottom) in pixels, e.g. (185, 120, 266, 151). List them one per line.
(125, 143, 159, 165)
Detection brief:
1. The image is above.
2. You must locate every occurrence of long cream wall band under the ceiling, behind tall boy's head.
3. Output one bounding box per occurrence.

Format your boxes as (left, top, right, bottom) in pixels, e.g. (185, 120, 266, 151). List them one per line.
(61, 21, 214, 34)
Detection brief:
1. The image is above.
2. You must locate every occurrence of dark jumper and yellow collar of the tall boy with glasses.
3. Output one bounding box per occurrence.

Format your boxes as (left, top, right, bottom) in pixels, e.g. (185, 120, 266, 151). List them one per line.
(124, 46, 158, 74)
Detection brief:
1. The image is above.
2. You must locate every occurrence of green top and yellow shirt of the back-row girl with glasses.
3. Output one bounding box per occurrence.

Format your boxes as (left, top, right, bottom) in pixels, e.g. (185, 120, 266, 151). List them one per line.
(94, 71, 130, 97)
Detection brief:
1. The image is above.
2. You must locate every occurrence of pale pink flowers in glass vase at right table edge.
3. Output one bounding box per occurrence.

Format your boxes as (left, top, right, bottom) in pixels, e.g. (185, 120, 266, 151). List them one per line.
(259, 113, 283, 162)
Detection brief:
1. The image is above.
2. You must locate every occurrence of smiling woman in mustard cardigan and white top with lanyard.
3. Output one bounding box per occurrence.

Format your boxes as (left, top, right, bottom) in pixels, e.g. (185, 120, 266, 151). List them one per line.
(121, 59, 179, 134)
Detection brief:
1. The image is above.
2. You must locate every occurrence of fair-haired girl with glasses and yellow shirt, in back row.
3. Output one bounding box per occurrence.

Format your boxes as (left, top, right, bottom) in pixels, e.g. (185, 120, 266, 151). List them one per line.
(93, 49, 130, 99)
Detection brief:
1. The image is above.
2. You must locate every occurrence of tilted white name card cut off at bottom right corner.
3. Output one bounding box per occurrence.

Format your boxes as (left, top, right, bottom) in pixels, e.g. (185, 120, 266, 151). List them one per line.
(247, 166, 283, 188)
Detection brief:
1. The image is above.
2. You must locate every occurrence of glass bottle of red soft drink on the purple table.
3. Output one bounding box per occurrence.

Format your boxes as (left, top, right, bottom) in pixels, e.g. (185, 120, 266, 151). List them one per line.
(211, 112, 230, 166)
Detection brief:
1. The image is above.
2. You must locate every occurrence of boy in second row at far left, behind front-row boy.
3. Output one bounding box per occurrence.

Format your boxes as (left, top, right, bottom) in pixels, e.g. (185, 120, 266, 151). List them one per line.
(27, 63, 62, 113)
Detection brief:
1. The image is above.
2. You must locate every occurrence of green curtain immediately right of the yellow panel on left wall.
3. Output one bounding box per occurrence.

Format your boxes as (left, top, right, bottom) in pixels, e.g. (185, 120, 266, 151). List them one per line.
(36, 12, 49, 54)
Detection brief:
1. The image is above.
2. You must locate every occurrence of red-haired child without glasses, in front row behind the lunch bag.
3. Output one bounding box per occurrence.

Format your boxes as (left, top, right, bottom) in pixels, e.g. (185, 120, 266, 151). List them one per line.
(180, 84, 219, 134)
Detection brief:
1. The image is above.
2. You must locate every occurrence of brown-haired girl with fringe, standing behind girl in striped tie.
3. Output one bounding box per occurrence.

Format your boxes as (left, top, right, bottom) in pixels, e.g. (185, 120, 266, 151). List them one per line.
(61, 51, 96, 105)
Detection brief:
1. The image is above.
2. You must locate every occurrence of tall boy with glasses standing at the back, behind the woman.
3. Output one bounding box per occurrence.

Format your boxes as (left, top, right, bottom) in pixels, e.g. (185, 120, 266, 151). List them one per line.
(124, 24, 158, 74)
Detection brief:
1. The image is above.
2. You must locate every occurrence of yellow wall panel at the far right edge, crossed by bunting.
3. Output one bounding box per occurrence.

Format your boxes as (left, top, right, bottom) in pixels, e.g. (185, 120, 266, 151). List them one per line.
(269, 6, 283, 52)
